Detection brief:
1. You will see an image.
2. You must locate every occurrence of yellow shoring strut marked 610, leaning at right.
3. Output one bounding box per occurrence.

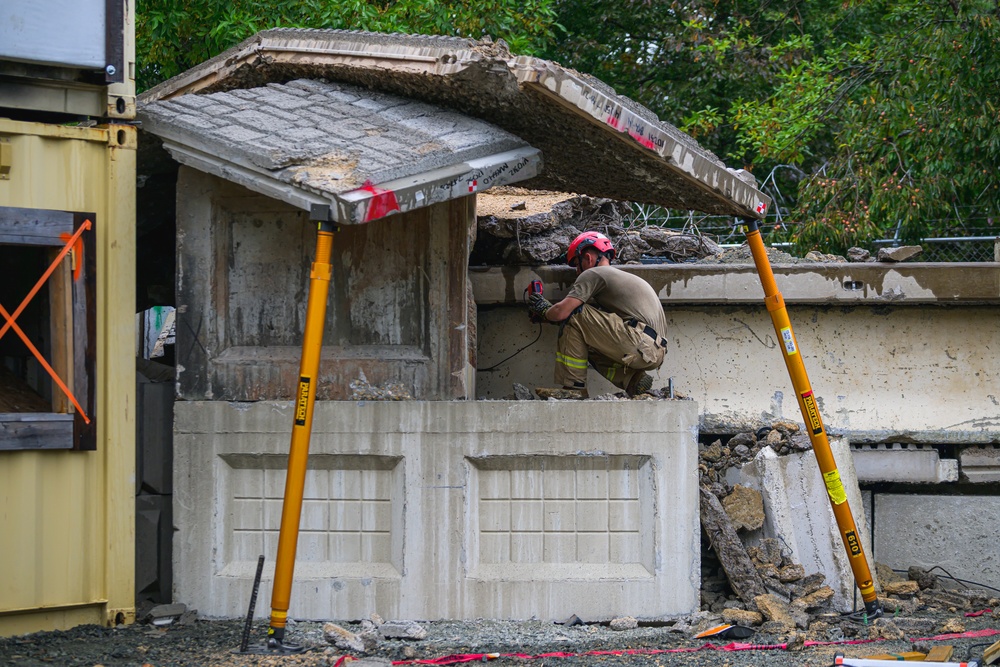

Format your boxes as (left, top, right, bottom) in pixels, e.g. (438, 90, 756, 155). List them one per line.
(745, 220, 882, 619)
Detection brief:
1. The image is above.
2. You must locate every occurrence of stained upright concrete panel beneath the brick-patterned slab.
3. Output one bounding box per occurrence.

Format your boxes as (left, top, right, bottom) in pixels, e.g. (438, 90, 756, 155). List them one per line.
(177, 167, 475, 401)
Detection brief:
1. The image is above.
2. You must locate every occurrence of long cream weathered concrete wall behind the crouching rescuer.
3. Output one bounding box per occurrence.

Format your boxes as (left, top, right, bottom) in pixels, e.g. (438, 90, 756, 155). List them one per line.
(471, 265, 1000, 443)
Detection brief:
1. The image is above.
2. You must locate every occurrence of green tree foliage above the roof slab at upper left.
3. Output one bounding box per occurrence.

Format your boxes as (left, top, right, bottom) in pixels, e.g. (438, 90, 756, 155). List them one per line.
(135, 0, 555, 91)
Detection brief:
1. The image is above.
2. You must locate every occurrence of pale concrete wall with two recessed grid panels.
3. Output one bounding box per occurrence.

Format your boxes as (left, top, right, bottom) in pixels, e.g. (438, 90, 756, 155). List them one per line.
(174, 401, 700, 620)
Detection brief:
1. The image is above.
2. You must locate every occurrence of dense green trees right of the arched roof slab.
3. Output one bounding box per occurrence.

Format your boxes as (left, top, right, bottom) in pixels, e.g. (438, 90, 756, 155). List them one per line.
(548, 0, 1000, 252)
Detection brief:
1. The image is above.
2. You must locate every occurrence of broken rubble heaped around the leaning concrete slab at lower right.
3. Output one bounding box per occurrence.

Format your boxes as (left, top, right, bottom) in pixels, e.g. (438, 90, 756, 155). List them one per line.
(698, 422, 1000, 646)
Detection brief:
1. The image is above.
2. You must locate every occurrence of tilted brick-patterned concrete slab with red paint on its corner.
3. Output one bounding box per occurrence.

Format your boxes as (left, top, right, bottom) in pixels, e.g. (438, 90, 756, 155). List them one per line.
(140, 79, 540, 224)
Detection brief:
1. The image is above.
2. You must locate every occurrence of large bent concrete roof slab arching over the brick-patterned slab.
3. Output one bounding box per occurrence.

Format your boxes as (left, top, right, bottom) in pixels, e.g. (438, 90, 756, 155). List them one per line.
(139, 29, 770, 218)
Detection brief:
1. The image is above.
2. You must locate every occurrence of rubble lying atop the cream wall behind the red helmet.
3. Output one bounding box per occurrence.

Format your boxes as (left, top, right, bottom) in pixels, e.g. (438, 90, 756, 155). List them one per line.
(469, 187, 921, 266)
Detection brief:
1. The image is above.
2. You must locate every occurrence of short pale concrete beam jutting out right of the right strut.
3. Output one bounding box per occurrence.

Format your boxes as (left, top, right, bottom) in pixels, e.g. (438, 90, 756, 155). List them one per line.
(852, 443, 958, 484)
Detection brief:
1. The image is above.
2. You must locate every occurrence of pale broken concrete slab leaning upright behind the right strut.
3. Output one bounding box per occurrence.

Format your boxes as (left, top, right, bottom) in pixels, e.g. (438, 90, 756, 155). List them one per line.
(730, 438, 875, 611)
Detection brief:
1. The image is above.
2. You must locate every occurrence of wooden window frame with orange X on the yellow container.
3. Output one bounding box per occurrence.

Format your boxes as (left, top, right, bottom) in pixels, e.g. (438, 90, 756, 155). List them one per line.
(0, 206, 97, 451)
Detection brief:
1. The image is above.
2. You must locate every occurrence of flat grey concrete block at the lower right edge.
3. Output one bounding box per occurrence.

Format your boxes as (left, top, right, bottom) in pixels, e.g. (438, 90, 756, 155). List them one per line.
(873, 493, 1000, 588)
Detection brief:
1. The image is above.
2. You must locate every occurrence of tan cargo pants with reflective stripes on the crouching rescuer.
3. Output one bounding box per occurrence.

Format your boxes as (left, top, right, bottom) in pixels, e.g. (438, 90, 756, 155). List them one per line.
(555, 304, 666, 389)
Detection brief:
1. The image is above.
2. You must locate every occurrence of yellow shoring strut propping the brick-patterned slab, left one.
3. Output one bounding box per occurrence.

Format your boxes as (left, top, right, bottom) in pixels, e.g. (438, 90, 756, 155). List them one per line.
(267, 221, 337, 652)
